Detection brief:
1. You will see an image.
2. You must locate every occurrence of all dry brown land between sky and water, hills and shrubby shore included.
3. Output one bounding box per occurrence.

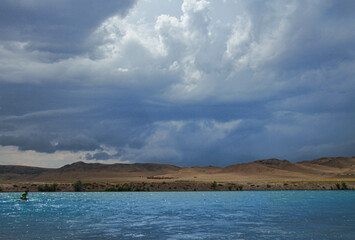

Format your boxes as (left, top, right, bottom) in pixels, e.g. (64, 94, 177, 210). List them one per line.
(0, 157, 355, 192)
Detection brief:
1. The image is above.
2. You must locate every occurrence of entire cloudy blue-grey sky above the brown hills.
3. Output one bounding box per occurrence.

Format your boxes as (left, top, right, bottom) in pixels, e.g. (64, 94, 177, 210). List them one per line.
(0, 0, 355, 167)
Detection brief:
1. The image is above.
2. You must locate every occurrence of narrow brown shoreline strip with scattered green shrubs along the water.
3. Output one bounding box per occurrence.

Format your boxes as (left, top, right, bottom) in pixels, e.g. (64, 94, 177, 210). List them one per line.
(0, 179, 355, 192)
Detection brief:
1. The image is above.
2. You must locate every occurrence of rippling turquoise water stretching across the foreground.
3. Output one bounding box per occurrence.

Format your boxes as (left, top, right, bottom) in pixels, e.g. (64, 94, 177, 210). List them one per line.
(0, 191, 355, 240)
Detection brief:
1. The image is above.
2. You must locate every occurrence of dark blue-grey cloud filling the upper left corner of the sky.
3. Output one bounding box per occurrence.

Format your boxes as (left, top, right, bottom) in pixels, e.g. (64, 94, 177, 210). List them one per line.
(0, 0, 135, 58)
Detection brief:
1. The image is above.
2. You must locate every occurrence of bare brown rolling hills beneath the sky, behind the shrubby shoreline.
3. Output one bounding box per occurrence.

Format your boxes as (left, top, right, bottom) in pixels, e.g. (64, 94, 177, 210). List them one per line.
(0, 157, 355, 182)
